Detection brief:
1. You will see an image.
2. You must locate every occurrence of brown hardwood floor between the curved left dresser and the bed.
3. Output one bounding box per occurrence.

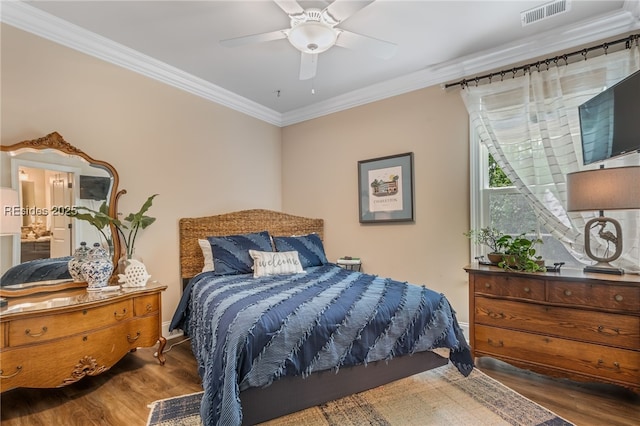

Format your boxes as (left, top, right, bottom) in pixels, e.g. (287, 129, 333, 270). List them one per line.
(0, 339, 202, 426)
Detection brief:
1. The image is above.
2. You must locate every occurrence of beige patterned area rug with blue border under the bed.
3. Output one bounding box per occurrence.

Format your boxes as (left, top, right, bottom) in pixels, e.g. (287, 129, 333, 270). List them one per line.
(147, 364, 572, 426)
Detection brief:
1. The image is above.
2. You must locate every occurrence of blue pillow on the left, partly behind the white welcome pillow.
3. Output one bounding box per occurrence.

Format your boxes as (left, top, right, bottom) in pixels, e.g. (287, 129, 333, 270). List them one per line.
(207, 231, 273, 275)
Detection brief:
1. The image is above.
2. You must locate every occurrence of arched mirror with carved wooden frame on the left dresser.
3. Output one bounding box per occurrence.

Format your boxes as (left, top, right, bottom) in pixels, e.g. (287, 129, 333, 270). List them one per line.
(0, 132, 125, 295)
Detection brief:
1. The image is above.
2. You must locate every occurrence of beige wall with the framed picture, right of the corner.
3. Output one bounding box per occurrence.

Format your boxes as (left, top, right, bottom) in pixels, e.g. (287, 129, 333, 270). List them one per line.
(282, 87, 469, 321)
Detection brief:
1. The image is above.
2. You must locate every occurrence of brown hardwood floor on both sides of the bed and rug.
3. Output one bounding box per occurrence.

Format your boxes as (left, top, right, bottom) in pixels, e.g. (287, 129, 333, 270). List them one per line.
(0, 339, 640, 426)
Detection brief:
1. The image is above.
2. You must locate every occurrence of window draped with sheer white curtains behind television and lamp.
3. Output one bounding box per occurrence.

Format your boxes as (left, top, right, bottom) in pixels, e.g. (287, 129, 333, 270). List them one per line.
(461, 45, 640, 271)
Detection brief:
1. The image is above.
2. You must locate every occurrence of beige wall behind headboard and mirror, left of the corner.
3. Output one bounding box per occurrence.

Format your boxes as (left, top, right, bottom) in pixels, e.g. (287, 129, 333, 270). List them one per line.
(1, 24, 282, 328)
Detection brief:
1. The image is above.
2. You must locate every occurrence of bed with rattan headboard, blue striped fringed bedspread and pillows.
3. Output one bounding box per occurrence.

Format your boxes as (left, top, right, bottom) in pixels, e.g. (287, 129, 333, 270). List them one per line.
(170, 210, 473, 426)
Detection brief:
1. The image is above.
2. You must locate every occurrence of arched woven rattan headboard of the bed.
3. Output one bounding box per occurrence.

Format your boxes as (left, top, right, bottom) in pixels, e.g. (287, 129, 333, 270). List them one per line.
(179, 209, 324, 280)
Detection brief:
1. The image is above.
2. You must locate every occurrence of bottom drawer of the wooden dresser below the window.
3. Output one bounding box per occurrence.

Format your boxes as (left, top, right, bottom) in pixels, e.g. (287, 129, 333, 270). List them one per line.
(473, 325, 640, 387)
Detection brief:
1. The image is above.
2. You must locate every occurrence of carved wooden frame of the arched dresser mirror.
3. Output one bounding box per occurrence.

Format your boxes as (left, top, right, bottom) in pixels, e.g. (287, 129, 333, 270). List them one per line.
(0, 132, 127, 279)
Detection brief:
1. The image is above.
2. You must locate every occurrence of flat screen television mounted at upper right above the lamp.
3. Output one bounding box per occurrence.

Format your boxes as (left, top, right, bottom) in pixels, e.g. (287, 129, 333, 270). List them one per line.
(578, 71, 640, 165)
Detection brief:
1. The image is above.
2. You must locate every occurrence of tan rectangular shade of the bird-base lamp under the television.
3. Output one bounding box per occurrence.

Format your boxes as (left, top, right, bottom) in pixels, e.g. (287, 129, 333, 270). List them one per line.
(567, 166, 640, 212)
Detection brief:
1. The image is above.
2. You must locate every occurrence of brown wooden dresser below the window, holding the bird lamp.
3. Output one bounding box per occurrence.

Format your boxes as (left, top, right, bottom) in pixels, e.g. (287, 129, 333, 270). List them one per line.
(465, 265, 640, 392)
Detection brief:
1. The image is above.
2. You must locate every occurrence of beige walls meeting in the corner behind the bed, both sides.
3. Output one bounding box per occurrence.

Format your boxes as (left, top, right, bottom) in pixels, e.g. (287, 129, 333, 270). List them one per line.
(1, 24, 469, 330)
